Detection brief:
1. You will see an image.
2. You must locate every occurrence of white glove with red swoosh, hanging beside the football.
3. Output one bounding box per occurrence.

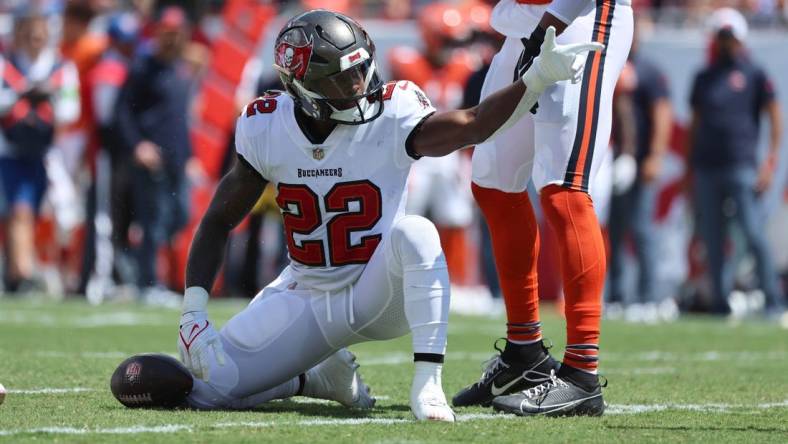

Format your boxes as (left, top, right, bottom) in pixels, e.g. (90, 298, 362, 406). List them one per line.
(178, 287, 225, 381)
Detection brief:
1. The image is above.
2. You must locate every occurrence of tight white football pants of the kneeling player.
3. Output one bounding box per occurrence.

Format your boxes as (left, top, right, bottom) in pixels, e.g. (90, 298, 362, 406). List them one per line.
(188, 216, 449, 409)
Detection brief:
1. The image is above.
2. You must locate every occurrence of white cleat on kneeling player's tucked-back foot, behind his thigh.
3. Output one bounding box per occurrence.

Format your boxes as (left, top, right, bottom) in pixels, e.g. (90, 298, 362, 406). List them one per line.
(302, 348, 375, 409)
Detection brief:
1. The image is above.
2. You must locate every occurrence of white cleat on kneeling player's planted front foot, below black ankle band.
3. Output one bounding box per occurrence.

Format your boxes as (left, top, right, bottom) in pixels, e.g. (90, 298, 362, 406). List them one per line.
(410, 362, 455, 422)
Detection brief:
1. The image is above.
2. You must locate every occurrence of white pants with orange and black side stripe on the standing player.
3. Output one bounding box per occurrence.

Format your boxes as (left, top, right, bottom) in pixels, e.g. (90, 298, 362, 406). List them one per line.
(473, 0, 633, 194)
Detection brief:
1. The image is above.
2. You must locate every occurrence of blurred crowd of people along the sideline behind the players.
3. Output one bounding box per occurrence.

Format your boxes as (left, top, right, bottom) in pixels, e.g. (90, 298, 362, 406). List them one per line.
(0, 0, 788, 322)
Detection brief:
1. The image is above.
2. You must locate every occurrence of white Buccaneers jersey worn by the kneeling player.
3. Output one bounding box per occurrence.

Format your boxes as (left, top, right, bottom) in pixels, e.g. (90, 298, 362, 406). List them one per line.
(235, 81, 435, 291)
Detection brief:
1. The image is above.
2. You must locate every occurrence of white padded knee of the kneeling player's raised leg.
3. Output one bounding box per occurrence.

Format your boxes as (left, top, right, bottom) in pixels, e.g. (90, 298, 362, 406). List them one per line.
(390, 215, 446, 275)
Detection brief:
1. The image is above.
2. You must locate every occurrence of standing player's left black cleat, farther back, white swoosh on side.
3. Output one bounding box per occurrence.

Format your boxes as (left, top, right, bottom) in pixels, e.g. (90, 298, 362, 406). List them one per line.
(451, 342, 561, 407)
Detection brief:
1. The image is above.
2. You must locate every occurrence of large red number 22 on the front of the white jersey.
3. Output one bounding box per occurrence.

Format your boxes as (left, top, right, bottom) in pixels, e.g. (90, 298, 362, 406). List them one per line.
(276, 180, 383, 267)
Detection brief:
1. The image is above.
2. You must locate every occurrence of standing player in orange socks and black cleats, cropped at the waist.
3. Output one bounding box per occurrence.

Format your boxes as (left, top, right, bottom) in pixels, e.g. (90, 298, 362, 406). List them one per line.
(452, 0, 633, 416)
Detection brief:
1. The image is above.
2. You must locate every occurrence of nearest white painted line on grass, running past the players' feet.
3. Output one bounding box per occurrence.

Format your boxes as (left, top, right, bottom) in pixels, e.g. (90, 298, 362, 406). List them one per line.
(0, 399, 788, 436)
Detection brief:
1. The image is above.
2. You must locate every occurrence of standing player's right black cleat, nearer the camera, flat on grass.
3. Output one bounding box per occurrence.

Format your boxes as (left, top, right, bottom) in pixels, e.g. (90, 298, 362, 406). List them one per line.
(492, 371, 607, 416)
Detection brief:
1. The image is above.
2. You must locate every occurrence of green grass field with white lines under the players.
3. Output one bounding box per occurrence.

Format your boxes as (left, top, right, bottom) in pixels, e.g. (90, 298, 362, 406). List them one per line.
(0, 298, 788, 443)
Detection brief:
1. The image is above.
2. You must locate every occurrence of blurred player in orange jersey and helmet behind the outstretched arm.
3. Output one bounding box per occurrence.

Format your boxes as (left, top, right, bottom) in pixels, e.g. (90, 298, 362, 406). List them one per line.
(389, 2, 481, 285)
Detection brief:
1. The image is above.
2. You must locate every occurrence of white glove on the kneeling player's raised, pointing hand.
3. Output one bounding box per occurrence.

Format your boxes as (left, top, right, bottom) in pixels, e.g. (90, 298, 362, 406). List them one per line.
(522, 26, 605, 94)
